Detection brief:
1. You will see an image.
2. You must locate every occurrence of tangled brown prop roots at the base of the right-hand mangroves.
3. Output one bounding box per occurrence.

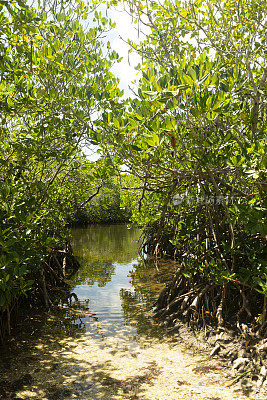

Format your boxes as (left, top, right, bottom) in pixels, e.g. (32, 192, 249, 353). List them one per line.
(152, 269, 267, 337)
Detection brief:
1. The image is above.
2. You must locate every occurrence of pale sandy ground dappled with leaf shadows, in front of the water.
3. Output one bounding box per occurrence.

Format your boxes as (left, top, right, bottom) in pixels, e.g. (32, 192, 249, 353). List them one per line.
(7, 335, 254, 400)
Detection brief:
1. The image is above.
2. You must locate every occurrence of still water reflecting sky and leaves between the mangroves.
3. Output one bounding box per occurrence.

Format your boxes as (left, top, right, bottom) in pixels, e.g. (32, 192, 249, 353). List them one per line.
(68, 225, 169, 338)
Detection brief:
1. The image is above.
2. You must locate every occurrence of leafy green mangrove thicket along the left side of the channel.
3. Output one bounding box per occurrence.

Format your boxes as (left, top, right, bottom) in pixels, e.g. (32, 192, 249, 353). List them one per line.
(0, 0, 123, 340)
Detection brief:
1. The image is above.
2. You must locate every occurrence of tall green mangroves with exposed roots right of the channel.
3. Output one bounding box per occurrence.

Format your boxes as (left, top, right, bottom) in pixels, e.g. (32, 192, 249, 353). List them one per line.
(99, 0, 267, 334)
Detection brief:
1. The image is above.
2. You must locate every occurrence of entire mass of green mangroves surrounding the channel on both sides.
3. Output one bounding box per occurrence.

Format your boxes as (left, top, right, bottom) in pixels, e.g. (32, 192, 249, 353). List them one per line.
(0, 0, 267, 340)
